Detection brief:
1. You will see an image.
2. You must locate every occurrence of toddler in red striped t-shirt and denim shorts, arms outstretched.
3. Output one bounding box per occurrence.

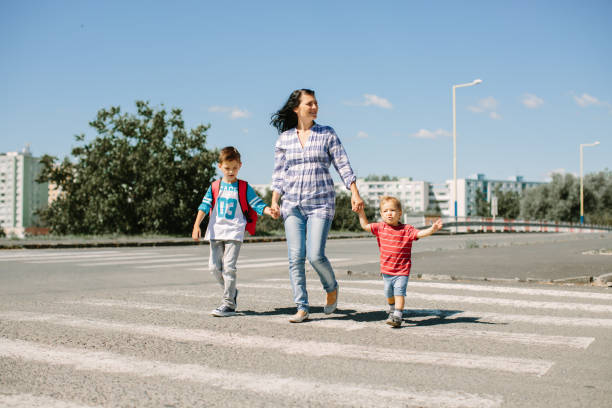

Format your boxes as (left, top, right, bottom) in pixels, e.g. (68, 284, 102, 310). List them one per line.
(358, 196, 442, 327)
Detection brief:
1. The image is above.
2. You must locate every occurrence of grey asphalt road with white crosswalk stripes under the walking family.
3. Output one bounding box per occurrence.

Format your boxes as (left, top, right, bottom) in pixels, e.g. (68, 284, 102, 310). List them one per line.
(0, 234, 612, 408)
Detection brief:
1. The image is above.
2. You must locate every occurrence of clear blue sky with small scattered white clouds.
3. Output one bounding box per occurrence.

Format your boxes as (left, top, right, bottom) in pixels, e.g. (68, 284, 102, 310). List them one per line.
(0, 0, 612, 184)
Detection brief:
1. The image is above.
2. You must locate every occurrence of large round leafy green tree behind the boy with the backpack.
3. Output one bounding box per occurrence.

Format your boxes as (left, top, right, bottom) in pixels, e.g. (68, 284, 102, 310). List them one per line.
(39, 101, 217, 235)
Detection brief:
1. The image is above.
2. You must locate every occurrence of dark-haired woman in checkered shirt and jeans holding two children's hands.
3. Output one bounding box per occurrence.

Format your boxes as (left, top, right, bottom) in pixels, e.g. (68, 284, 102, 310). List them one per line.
(271, 89, 363, 323)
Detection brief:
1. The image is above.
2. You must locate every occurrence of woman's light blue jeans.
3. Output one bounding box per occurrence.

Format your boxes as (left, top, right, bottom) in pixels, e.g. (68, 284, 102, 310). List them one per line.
(285, 207, 338, 312)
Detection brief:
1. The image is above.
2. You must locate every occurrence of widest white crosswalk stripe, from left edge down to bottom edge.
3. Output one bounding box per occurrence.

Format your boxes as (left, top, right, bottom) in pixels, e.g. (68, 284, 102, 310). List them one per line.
(0, 338, 503, 408)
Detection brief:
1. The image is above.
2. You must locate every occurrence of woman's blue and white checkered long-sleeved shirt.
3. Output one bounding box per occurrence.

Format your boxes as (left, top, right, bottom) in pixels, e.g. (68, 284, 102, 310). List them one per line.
(272, 123, 357, 219)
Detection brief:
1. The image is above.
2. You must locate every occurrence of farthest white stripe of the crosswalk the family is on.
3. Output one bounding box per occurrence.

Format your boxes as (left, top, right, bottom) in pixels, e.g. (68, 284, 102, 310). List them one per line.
(332, 279, 612, 300)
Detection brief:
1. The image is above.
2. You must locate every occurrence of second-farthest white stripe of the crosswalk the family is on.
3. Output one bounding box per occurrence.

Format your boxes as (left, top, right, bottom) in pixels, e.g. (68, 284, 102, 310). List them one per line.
(242, 284, 612, 313)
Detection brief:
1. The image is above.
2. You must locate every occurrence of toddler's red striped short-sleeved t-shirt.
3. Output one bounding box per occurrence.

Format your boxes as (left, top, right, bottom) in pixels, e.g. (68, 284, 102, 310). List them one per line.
(370, 222, 419, 276)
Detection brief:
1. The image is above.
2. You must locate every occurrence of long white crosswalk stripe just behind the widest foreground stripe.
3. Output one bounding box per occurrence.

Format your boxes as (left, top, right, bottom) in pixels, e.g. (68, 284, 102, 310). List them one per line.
(0, 312, 554, 376)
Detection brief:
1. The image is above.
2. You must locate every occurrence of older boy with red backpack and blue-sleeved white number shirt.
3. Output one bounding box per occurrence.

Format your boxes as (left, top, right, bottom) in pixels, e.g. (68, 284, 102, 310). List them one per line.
(191, 146, 278, 317)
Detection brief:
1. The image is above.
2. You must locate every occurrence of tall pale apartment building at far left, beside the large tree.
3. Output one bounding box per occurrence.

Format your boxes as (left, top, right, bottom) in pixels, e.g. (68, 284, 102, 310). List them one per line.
(0, 146, 49, 237)
